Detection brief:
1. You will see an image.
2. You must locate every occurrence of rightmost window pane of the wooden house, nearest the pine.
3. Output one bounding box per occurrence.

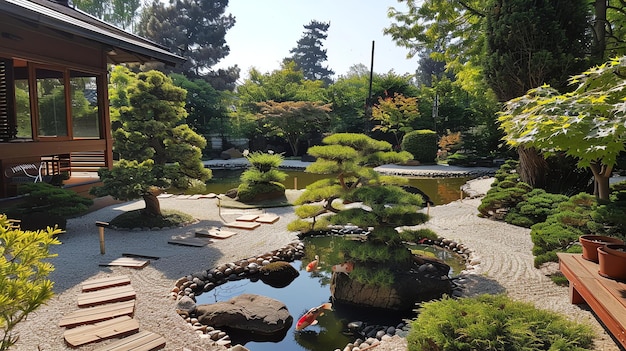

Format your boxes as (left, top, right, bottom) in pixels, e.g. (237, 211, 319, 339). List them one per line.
(70, 71, 100, 138)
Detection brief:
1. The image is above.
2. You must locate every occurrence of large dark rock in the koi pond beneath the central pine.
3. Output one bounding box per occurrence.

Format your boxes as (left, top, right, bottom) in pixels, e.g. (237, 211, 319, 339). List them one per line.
(330, 261, 452, 311)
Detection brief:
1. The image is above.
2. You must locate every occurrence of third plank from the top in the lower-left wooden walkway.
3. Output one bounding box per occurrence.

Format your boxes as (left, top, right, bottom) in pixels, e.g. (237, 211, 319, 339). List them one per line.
(59, 300, 135, 328)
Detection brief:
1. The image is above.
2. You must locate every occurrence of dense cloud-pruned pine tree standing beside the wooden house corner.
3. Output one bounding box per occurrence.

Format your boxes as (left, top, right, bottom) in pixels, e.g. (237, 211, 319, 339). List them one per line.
(91, 69, 211, 216)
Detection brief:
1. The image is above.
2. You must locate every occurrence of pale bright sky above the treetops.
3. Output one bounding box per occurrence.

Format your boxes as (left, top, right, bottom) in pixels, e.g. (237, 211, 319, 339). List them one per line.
(213, 0, 417, 78)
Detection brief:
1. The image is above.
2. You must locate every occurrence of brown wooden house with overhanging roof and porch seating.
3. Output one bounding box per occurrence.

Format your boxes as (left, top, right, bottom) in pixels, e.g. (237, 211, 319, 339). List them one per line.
(0, 0, 184, 198)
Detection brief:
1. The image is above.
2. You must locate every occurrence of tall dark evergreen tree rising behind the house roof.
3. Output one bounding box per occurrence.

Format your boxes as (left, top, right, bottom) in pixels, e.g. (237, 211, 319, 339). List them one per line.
(137, 0, 239, 89)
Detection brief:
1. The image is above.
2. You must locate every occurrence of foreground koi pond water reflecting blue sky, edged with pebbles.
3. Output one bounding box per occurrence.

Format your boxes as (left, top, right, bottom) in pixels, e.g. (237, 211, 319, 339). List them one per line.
(196, 236, 465, 351)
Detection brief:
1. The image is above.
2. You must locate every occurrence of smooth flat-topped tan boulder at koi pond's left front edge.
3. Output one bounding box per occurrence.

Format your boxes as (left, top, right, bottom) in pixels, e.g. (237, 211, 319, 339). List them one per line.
(196, 294, 293, 335)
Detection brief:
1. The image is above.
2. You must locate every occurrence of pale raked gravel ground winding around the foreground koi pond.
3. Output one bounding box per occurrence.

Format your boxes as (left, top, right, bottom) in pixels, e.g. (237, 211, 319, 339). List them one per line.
(8, 179, 619, 351)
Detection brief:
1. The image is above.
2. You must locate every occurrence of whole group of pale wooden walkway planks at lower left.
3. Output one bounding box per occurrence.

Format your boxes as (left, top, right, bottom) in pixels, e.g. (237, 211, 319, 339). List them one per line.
(59, 275, 166, 351)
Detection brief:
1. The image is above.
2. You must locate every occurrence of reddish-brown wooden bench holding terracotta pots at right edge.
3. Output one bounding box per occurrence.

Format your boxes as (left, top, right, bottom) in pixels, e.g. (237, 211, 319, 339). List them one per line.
(557, 253, 626, 347)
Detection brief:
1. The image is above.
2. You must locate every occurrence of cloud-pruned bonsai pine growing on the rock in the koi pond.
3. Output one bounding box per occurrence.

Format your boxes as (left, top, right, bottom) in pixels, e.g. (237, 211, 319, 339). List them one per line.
(289, 133, 428, 285)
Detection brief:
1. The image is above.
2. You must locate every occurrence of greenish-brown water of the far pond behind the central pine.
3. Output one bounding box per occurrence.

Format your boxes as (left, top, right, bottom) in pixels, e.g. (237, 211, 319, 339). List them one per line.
(206, 169, 472, 205)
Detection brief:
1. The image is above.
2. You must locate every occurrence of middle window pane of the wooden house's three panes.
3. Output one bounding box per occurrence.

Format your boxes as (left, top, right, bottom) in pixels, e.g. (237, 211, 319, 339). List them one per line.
(36, 68, 67, 137)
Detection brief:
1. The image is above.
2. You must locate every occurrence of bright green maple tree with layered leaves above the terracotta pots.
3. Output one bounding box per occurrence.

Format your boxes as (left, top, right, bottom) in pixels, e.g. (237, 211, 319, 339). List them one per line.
(499, 57, 626, 199)
